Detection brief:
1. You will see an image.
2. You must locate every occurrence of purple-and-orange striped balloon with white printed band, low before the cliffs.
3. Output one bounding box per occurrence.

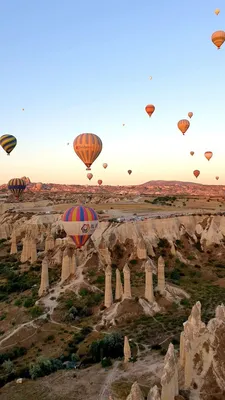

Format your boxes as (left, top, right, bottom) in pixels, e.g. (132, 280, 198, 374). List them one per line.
(62, 206, 98, 248)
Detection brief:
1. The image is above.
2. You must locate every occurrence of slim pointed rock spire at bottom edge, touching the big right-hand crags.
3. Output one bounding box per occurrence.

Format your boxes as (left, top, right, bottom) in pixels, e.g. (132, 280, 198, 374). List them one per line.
(161, 343, 179, 400)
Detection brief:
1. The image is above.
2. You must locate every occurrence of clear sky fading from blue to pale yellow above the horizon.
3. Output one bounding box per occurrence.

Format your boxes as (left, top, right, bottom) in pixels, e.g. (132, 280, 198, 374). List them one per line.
(0, 0, 225, 185)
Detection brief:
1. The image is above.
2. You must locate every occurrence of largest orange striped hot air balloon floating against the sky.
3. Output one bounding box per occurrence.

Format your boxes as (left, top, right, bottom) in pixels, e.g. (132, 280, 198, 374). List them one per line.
(73, 133, 102, 171)
